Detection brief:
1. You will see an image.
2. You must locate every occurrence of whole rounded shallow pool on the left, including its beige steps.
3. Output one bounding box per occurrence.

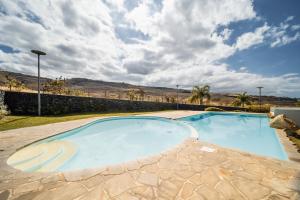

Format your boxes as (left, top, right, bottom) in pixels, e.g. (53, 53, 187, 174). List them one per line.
(7, 117, 195, 172)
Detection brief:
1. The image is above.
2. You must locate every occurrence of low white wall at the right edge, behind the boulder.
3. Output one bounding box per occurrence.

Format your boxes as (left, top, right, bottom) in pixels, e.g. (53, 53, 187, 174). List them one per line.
(271, 107, 300, 127)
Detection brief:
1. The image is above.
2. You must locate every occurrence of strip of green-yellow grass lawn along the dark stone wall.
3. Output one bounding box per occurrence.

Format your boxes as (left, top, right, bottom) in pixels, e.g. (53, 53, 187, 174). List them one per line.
(0, 111, 170, 131)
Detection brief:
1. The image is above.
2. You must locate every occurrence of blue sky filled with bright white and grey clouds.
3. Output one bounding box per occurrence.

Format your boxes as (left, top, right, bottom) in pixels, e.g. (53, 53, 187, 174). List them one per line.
(0, 0, 300, 97)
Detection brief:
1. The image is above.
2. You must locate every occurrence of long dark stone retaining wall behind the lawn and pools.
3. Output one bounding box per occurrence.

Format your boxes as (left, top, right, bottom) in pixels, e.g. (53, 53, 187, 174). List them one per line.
(4, 91, 241, 115)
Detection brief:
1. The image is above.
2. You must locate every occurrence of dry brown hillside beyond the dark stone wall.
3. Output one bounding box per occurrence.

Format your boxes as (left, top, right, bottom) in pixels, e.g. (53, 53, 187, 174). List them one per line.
(0, 71, 297, 105)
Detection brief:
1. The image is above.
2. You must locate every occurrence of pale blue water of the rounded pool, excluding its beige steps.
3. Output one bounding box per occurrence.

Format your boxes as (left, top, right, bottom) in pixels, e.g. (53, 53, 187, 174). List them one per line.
(41, 117, 191, 171)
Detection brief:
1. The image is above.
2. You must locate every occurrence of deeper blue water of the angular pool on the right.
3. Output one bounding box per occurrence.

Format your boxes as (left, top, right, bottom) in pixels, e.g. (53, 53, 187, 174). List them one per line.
(180, 112, 288, 160)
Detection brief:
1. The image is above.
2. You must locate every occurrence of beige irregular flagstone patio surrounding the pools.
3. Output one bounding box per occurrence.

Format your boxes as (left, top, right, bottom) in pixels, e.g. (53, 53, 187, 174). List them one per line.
(0, 111, 300, 200)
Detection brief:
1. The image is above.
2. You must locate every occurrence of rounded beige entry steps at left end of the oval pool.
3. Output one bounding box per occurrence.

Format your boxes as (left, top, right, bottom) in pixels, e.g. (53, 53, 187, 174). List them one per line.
(7, 141, 76, 172)
